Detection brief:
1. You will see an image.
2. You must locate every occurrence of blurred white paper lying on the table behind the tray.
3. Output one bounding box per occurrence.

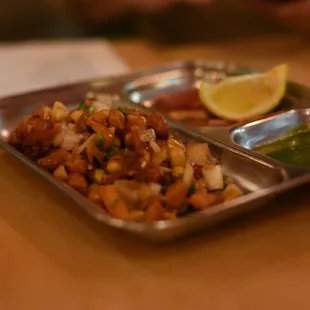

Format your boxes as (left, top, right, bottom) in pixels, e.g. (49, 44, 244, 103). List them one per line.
(0, 40, 129, 97)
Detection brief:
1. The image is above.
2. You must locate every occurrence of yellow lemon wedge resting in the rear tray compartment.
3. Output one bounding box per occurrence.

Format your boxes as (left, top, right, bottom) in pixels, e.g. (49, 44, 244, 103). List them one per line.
(199, 64, 288, 121)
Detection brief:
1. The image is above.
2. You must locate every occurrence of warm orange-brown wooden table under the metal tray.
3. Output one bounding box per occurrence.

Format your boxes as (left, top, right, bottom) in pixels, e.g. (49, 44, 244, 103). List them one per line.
(0, 37, 310, 310)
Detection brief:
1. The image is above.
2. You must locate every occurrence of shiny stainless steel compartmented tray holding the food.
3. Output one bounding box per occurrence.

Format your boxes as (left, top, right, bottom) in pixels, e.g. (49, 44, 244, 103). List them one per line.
(0, 61, 310, 242)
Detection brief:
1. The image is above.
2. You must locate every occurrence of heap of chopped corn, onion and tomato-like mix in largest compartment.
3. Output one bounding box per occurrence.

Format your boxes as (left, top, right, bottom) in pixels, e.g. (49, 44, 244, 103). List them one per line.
(9, 99, 243, 221)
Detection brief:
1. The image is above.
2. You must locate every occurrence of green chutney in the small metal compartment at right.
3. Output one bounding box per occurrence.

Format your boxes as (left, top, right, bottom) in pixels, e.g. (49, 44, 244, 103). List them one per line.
(253, 125, 310, 168)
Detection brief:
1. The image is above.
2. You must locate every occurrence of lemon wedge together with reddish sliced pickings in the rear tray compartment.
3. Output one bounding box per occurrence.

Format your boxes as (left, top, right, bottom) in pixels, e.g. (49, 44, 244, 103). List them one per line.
(153, 65, 288, 127)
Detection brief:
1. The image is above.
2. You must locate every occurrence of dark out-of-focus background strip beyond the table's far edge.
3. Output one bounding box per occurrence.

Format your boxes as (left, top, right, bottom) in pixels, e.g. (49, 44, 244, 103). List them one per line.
(0, 0, 288, 44)
